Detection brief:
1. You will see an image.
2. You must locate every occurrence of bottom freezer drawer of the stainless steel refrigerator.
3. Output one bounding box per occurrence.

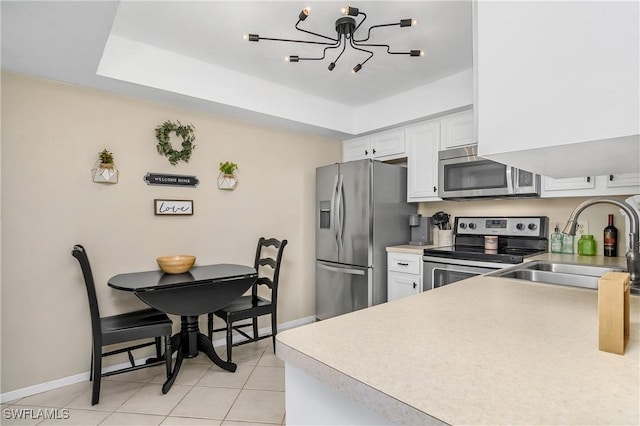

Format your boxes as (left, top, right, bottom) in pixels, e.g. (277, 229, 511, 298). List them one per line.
(316, 261, 373, 320)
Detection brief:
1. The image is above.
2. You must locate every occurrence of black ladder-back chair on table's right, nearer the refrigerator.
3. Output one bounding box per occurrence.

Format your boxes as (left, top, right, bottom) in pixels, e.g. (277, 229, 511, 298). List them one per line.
(208, 237, 287, 362)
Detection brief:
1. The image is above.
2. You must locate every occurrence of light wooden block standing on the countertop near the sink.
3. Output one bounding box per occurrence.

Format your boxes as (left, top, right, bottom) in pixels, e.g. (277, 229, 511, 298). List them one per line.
(598, 272, 629, 355)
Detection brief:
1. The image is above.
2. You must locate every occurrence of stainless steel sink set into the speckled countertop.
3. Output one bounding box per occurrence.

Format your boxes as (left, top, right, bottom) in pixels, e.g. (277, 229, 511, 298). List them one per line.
(487, 260, 624, 290)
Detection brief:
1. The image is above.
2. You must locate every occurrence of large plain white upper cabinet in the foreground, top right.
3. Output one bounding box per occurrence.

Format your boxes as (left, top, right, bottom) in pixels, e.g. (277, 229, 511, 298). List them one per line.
(473, 1, 640, 178)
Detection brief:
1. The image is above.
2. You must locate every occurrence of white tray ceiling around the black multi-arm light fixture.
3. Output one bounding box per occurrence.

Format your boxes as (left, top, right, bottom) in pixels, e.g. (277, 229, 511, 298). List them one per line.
(1, 0, 472, 137)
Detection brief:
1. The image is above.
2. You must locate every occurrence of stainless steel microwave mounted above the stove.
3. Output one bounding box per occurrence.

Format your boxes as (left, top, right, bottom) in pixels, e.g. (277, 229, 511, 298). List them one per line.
(438, 145, 540, 199)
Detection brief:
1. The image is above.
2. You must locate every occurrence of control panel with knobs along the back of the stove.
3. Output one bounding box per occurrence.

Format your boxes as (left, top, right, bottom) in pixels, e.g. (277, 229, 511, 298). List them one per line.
(454, 216, 549, 238)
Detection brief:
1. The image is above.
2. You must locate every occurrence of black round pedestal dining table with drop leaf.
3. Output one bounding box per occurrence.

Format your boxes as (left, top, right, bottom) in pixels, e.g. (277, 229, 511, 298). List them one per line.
(108, 263, 258, 393)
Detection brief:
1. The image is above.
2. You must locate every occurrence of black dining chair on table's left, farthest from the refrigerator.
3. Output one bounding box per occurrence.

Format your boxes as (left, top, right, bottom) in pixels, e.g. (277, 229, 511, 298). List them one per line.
(71, 244, 172, 405)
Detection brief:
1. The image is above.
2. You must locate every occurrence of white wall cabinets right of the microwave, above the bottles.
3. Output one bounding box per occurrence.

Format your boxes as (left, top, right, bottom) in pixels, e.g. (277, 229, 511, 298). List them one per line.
(541, 173, 640, 198)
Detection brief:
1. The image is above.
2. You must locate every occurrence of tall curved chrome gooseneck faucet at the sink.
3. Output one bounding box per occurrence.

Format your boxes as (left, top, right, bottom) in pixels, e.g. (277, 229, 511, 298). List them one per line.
(562, 197, 640, 288)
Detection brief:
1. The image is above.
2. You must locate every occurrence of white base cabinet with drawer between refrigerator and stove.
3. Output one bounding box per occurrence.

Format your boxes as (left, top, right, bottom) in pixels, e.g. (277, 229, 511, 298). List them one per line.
(387, 252, 423, 301)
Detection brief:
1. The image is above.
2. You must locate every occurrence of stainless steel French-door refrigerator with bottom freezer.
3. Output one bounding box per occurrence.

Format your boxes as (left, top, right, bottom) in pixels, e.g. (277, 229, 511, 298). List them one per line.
(316, 160, 417, 320)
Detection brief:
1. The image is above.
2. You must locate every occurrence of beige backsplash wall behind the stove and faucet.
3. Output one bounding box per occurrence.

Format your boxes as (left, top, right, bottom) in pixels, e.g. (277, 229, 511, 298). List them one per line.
(418, 196, 628, 256)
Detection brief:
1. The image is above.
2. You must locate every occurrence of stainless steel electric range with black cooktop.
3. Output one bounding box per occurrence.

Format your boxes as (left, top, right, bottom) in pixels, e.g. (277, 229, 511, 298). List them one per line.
(423, 216, 549, 289)
